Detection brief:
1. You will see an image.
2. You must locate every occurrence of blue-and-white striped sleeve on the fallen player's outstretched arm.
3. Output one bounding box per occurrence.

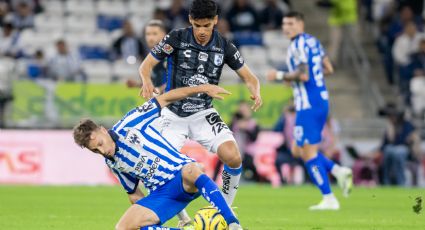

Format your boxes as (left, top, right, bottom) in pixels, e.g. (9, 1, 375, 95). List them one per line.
(112, 98, 161, 135)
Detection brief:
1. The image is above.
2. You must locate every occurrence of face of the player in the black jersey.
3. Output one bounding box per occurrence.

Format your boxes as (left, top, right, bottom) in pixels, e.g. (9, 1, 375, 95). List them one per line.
(189, 16, 218, 45)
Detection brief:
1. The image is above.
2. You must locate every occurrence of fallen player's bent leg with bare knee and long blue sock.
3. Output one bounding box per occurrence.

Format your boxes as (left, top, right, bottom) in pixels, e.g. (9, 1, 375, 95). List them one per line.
(181, 163, 239, 225)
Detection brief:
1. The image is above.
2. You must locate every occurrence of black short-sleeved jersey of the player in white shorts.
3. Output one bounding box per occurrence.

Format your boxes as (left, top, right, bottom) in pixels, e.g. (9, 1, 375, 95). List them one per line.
(151, 27, 244, 117)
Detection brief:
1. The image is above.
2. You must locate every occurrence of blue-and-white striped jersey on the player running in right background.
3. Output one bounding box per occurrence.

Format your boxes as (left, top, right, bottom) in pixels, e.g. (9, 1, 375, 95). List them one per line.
(286, 33, 329, 111)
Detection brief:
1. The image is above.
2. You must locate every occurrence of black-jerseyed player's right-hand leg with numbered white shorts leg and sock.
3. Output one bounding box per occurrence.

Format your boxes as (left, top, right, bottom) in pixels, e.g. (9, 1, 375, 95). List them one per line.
(189, 108, 242, 205)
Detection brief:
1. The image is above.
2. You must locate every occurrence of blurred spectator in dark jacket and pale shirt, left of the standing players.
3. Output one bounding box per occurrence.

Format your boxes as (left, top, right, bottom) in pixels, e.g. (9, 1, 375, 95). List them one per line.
(112, 20, 145, 64)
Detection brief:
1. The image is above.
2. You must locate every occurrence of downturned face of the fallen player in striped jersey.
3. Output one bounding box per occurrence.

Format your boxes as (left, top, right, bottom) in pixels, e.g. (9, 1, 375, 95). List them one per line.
(87, 127, 115, 157)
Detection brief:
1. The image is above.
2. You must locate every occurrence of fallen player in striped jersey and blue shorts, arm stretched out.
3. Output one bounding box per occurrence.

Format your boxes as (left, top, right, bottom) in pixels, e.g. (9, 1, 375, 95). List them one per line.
(74, 84, 242, 230)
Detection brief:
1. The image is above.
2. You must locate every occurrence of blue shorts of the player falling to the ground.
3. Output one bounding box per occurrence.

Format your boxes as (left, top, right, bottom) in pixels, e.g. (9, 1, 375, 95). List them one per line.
(136, 170, 200, 224)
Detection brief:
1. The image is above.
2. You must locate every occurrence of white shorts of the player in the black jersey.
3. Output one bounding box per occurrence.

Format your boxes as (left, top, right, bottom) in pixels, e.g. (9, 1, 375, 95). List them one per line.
(153, 108, 236, 153)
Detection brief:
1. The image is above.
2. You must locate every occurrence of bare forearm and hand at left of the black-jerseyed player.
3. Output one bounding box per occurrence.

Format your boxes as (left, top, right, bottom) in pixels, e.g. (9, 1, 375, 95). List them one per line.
(139, 53, 159, 99)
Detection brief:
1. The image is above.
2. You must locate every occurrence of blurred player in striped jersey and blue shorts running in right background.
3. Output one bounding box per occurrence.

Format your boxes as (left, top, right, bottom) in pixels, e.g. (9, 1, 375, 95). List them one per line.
(268, 12, 352, 210)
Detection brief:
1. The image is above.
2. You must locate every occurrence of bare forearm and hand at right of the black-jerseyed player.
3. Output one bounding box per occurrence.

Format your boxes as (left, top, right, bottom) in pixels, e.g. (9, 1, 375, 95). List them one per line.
(237, 64, 263, 111)
